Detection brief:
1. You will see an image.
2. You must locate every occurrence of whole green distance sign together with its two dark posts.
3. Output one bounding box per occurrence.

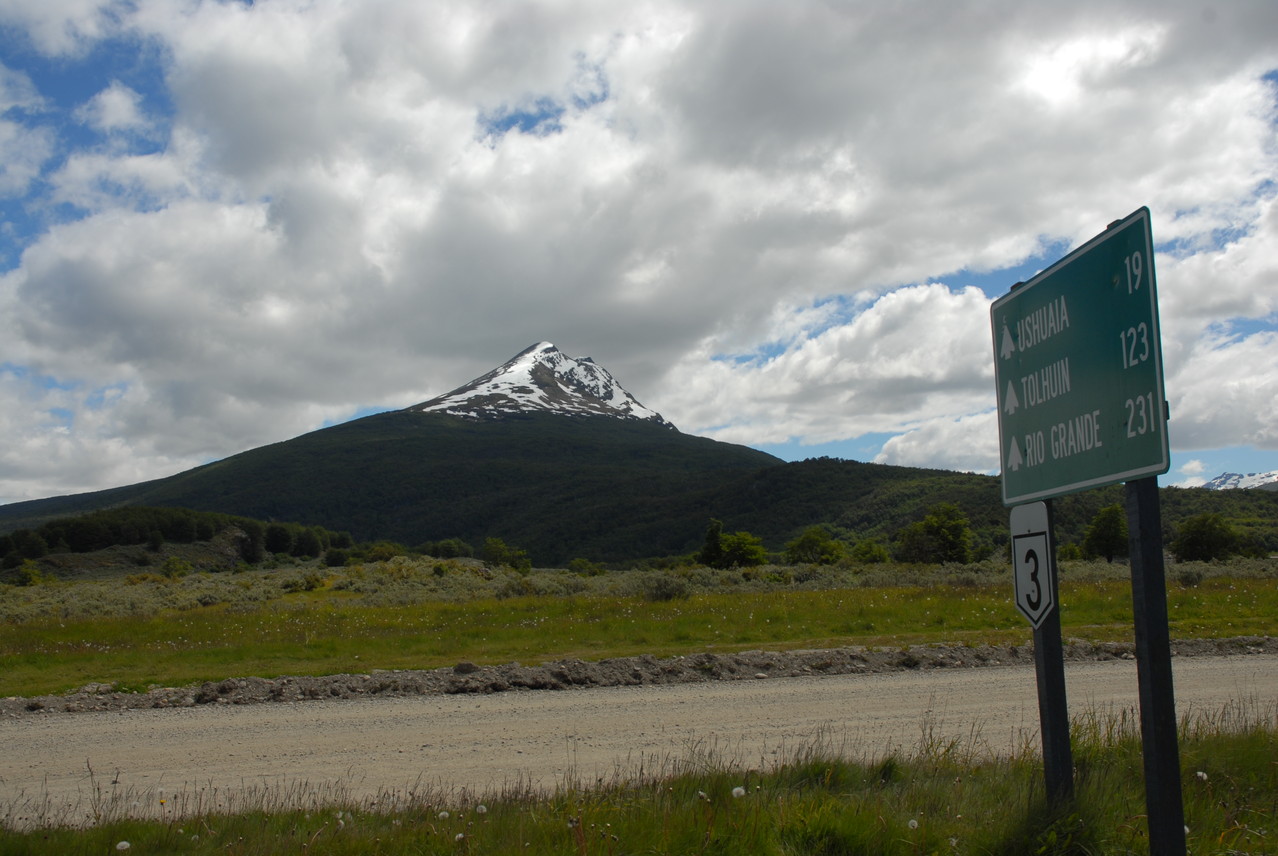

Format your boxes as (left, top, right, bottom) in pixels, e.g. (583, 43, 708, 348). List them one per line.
(989, 208, 1185, 856)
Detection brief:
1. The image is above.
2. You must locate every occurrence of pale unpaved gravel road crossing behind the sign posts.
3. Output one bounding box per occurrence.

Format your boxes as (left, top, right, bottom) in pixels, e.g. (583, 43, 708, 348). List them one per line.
(0, 645, 1278, 825)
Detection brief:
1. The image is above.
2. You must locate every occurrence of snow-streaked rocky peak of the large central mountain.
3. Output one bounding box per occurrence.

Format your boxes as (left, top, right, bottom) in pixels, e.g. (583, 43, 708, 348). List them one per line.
(406, 342, 674, 428)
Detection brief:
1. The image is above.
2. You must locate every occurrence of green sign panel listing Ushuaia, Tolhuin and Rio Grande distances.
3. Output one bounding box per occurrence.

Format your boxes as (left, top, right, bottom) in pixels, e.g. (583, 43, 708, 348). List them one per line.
(989, 208, 1171, 505)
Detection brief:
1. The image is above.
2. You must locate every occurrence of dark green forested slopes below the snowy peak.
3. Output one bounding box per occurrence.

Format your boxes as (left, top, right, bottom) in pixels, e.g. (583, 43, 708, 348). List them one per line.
(0, 411, 1278, 567)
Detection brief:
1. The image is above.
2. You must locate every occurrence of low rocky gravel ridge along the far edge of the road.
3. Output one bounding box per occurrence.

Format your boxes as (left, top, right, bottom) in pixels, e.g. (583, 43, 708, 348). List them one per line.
(0, 636, 1278, 717)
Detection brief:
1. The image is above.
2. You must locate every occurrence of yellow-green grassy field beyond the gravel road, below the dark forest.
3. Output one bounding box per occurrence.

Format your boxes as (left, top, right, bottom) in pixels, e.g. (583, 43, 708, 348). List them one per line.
(0, 560, 1278, 696)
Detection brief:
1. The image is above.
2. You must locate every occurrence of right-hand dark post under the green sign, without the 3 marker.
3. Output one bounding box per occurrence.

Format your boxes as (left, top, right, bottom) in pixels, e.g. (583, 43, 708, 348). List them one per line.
(1126, 478, 1186, 856)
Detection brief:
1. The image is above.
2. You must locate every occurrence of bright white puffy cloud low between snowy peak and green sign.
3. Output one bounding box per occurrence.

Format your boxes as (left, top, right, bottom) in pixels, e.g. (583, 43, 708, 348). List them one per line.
(661, 284, 997, 449)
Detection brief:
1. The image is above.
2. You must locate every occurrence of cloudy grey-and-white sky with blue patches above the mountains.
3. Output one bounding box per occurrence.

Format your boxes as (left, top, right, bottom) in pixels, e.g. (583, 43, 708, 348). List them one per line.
(0, 0, 1278, 502)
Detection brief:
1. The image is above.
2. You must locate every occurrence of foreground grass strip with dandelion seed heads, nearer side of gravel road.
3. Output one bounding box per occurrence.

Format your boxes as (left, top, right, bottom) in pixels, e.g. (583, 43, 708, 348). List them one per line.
(0, 701, 1278, 856)
